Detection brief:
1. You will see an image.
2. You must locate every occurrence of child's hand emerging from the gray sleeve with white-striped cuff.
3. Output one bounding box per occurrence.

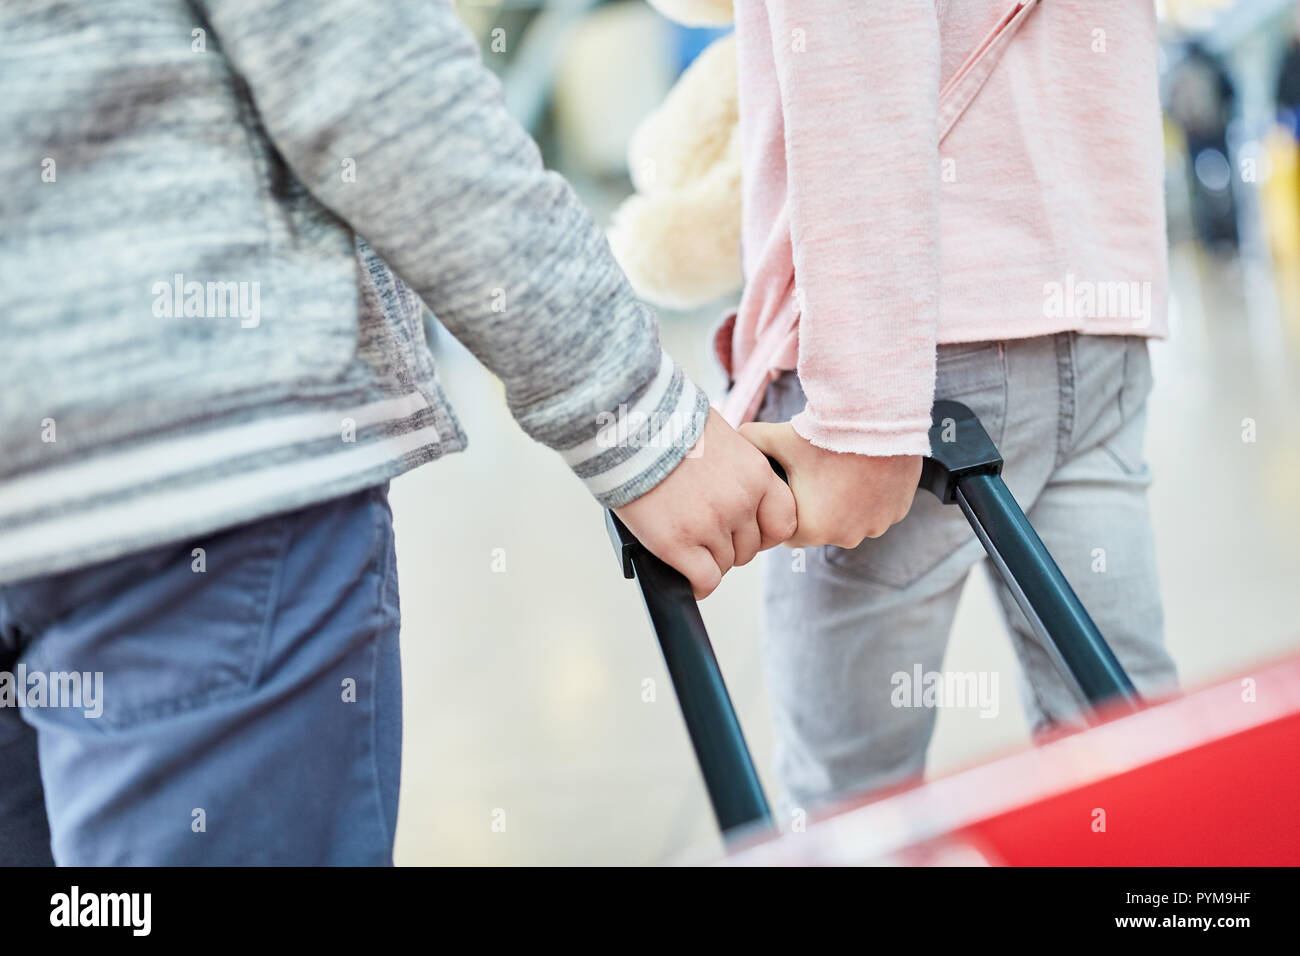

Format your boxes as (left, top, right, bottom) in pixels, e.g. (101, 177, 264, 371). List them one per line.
(614, 410, 796, 600)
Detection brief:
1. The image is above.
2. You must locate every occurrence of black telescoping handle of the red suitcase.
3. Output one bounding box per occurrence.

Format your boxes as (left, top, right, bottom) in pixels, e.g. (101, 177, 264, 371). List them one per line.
(606, 401, 1140, 834)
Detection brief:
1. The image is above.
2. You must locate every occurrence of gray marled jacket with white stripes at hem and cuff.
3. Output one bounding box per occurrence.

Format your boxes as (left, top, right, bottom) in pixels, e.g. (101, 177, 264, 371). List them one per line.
(0, 0, 707, 581)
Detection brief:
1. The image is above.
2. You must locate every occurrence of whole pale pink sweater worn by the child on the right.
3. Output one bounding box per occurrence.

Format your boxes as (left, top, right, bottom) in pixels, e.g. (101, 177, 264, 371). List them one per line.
(718, 0, 1166, 455)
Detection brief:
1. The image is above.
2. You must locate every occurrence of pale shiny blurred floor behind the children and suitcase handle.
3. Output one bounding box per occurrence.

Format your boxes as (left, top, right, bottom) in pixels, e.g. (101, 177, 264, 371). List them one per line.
(393, 250, 1300, 865)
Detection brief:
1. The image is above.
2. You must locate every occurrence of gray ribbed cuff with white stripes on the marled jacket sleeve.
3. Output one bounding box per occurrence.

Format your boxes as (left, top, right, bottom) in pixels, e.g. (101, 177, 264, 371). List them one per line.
(560, 352, 709, 507)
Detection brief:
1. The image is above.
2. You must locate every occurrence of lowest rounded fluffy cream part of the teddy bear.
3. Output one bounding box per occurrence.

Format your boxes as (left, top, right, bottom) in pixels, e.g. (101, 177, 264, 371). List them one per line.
(608, 127, 741, 308)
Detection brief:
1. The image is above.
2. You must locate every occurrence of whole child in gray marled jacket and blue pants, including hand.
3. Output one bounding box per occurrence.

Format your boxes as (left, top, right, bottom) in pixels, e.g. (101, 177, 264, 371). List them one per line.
(0, 0, 794, 864)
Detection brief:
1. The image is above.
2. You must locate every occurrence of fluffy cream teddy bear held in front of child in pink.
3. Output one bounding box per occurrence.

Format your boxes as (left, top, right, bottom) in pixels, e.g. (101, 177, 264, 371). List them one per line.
(608, 0, 741, 310)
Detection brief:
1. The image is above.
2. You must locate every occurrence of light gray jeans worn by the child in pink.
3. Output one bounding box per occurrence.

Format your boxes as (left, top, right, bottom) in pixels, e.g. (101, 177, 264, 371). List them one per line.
(759, 333, 1175, 806)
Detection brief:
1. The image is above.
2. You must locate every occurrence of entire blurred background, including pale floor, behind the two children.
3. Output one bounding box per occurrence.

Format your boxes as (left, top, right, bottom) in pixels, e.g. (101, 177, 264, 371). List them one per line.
(393, 0, 1300, 864)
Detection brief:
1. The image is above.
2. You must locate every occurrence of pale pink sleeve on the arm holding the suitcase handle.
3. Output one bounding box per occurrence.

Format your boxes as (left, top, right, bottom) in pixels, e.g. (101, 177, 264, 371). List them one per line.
(767, 0, 940, 455)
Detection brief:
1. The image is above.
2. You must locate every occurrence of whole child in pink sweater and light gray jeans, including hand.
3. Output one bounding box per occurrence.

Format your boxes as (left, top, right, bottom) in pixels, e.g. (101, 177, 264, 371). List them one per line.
(718, 0, 1174, 800)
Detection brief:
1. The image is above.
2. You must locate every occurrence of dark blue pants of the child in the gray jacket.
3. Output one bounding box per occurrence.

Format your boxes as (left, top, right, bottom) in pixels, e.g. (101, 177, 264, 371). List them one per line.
(0, 486, 402, 865)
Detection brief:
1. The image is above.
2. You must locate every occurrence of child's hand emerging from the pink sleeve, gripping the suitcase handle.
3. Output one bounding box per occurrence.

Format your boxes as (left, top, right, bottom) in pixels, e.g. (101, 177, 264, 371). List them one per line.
(740, 421, 920, 548)
